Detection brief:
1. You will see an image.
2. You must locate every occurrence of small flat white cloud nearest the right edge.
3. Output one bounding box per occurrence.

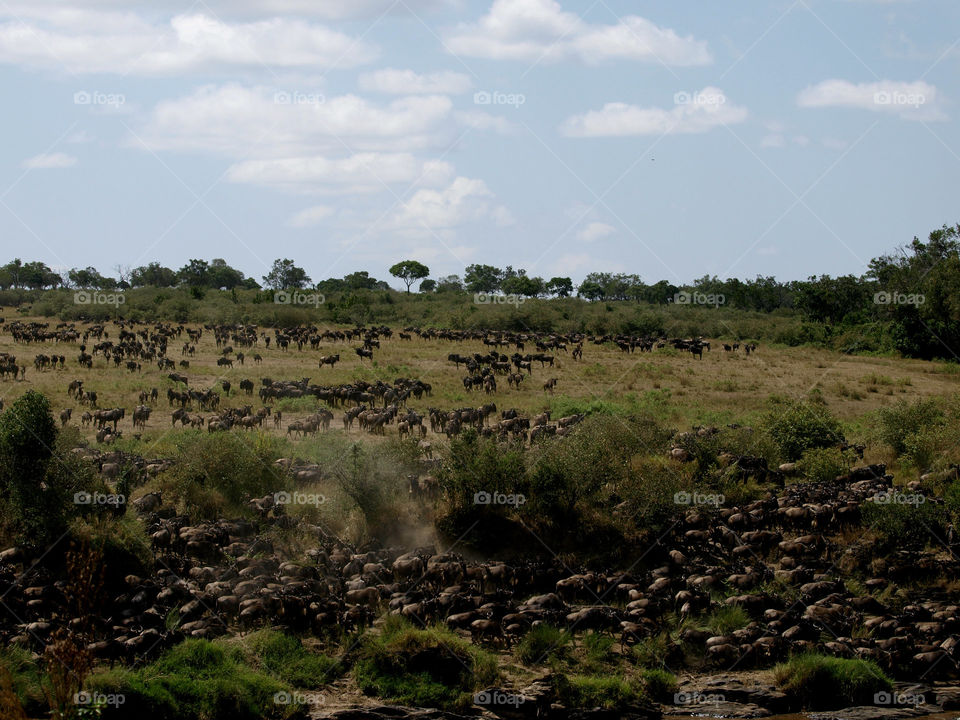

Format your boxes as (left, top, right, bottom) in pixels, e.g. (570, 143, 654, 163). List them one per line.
(797, 79, 946, 120)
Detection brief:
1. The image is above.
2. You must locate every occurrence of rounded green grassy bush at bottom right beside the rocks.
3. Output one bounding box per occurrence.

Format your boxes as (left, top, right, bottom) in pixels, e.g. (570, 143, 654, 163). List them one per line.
(773, 653, 893, 710)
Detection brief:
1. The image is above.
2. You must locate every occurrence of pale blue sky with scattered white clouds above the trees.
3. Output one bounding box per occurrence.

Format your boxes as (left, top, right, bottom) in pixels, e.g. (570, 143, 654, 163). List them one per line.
(0, 0, 960, 287)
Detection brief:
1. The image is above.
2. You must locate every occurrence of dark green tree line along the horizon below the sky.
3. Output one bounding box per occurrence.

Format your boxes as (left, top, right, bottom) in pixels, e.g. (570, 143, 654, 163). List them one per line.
(0, 224, 960, 360)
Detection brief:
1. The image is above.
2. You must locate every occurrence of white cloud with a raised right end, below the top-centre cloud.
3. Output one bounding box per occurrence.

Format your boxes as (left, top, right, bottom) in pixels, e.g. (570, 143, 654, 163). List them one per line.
(560, 87, 747, 137)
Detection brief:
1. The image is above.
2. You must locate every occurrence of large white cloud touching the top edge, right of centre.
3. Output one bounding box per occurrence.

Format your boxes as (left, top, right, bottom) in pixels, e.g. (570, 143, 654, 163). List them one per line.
(445, 0, 712, 66)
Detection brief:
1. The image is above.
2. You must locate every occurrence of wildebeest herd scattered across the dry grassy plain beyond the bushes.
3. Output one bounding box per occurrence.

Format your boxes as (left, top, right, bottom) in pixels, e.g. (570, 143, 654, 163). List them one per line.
(0, 320, 744, 443)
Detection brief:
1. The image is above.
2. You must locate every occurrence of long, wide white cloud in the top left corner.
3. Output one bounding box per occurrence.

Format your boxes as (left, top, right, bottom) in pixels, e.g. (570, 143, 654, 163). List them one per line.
(0, 8, 377, 75)
